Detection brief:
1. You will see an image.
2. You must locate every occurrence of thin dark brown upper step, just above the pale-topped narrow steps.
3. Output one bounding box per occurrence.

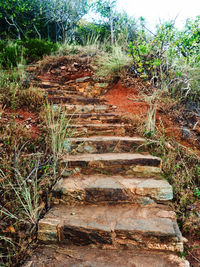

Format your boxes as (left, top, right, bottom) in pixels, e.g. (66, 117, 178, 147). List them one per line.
(48, 95, 105, 105)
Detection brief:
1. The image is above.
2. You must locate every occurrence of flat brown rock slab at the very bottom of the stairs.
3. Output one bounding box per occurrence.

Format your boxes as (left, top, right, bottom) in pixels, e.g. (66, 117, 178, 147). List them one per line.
(23, 245, 189, 267)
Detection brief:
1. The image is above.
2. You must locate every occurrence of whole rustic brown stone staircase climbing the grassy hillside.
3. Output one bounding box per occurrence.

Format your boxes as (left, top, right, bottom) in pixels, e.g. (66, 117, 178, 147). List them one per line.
(25, 76, 189, 267)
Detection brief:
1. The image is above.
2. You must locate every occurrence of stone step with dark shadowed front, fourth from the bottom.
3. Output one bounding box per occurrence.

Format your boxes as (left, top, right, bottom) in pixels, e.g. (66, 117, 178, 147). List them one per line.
(62, 153, 161, 176)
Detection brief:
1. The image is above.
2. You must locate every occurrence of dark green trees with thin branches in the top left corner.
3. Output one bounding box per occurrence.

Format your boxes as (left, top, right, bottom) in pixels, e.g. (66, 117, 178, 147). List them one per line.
(0, 0, 89, 41)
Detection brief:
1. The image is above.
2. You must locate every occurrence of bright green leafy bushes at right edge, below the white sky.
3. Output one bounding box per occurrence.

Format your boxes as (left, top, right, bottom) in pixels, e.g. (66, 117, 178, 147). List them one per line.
(128, 17, 200, 101)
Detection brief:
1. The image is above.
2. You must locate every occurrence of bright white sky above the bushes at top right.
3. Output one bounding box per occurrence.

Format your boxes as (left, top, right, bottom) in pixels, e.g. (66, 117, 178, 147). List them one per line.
(117, 0, 200, 29)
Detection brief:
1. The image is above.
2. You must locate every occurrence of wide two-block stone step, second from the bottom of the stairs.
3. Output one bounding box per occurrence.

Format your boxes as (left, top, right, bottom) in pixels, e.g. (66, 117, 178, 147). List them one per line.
(38, 204, 183, 252)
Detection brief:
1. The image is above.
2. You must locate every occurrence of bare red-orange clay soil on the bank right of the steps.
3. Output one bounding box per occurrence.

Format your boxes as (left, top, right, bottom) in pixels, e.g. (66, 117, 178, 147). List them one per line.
(104, 81, 200, 155)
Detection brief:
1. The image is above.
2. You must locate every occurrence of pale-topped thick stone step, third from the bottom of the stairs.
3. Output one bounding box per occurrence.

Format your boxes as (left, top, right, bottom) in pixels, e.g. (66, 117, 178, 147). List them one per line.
(52, 175, 173, 205)
